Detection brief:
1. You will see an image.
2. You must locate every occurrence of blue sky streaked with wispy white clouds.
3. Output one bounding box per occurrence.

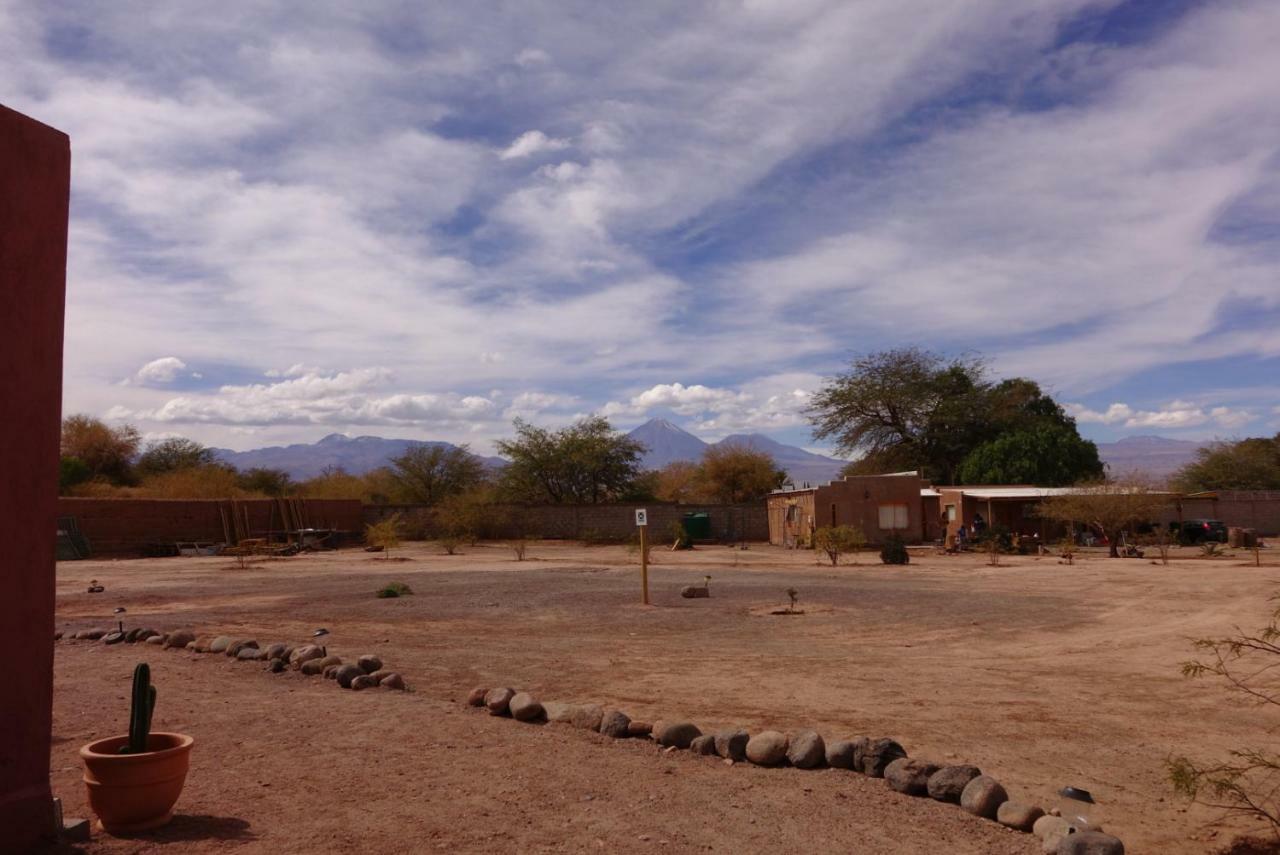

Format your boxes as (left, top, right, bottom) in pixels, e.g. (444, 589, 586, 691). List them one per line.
(0, 0, 1280, 452)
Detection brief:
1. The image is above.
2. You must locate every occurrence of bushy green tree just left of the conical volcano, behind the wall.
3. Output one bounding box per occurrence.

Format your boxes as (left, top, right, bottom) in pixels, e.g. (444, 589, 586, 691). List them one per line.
(497, 416, 644, 504)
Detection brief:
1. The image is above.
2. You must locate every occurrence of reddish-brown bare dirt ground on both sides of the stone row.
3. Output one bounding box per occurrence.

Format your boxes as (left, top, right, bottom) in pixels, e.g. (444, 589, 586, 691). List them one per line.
(45, 543, 1280, 854)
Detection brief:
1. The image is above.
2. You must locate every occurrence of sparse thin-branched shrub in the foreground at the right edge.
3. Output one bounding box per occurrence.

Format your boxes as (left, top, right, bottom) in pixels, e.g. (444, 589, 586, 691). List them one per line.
(1166, 598, 1280, 837)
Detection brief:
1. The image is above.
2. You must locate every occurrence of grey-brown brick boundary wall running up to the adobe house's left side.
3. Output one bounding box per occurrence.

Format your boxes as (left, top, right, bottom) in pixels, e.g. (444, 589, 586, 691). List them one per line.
(365, 500, 769, 543)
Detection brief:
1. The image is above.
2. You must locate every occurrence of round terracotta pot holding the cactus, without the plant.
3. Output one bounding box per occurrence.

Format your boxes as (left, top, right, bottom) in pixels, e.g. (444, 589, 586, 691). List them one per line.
(81, 733, 196, 835)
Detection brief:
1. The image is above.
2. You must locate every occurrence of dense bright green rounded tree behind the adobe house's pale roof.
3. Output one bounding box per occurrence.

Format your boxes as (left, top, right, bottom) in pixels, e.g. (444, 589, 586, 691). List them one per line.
(956, 424, 1102, 486)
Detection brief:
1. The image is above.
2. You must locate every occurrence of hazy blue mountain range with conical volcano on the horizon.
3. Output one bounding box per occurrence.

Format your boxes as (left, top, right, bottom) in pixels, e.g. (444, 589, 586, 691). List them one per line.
(214, 419, 1204, 486)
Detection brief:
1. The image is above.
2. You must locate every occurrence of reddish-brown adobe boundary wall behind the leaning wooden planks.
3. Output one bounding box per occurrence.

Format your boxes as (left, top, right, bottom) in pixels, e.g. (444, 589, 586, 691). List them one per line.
(59, 497, 365, 558)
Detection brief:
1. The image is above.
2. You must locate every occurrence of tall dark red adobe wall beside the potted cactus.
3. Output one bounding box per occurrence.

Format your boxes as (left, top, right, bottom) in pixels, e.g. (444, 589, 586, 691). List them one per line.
(0, 106, 72, 852)
